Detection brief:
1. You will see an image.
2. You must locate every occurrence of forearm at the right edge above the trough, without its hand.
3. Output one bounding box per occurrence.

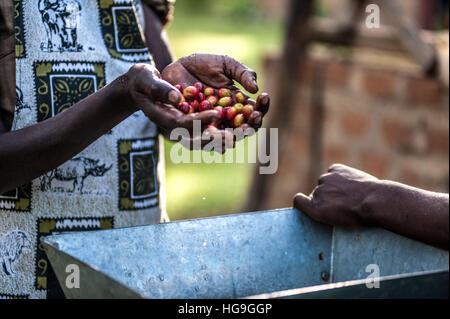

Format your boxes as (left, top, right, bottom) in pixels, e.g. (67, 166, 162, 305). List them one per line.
(362, 181, 449, 250)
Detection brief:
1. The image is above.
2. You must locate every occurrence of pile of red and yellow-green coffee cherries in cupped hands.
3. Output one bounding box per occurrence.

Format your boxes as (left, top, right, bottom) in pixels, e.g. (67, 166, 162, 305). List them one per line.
(175, 82, 254, 129)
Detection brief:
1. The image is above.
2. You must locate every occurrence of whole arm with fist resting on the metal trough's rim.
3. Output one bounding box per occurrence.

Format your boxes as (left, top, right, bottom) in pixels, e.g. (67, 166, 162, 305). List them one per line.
(294, 164, 449, 250)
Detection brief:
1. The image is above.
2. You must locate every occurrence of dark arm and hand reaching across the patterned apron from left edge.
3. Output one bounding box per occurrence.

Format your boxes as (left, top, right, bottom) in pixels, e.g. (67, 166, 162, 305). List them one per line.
(0, 64, 218, 193)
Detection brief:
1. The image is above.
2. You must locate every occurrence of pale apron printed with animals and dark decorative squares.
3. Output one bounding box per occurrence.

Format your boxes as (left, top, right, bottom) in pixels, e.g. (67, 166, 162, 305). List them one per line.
(0, 0, 167, 298)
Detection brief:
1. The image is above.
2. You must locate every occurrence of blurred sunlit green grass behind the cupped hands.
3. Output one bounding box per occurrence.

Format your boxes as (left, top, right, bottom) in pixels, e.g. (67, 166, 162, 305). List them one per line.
(165, 0, 282, 220)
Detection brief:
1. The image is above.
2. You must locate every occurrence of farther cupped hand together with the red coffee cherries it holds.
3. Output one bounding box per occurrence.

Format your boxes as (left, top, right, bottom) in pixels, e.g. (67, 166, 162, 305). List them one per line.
(162, 53, 270, 130)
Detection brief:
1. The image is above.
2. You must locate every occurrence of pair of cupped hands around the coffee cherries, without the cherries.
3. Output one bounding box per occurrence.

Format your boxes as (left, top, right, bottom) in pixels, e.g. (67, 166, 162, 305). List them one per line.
(118, 54, 270, 152)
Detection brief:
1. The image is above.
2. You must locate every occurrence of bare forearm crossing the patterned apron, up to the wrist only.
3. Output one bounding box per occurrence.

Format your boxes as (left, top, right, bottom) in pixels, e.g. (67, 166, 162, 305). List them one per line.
(0, 80, 137, 193)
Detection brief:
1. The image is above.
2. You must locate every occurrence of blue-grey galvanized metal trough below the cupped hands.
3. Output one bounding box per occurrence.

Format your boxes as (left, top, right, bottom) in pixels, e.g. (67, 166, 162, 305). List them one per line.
(42, 208, 449, 299)
